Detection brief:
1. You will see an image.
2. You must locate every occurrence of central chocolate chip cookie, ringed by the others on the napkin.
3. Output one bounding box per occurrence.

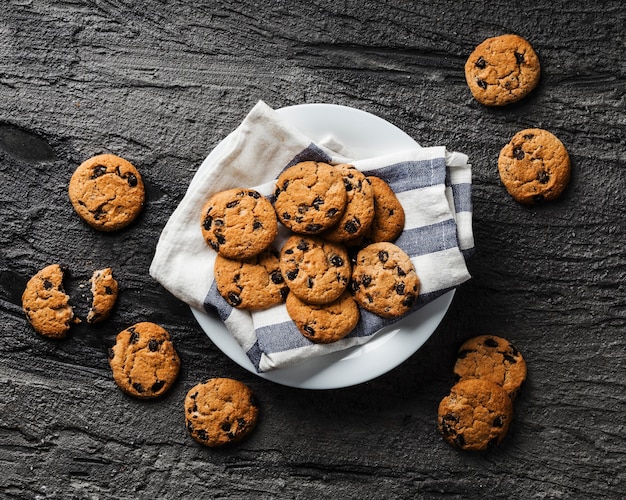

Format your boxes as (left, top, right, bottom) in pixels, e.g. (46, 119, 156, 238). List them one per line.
(280, 235, 351, 304)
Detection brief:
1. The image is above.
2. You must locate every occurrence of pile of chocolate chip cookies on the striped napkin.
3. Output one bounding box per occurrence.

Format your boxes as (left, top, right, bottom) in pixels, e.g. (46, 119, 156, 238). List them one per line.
(201, 161, 420, 343)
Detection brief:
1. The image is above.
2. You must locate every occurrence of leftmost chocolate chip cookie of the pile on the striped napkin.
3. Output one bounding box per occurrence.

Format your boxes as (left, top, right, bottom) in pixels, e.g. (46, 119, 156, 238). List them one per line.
(201, 188, 278, 259)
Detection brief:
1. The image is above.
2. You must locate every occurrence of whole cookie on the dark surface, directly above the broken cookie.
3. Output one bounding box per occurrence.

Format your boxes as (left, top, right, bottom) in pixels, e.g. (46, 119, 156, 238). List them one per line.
(69, 154, 145, 231)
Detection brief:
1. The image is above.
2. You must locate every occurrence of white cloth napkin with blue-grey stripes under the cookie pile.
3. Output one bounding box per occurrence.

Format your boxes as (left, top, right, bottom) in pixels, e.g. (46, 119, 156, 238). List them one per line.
(150, 101, 474, 372)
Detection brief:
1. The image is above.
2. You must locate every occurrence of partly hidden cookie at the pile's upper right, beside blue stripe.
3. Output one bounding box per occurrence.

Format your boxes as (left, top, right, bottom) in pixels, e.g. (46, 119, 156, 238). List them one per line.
(367, 176, 405, 243)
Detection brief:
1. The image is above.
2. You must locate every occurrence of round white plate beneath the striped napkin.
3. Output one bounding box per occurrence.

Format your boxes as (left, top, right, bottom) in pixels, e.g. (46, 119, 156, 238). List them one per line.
(192, 104, 454, 389)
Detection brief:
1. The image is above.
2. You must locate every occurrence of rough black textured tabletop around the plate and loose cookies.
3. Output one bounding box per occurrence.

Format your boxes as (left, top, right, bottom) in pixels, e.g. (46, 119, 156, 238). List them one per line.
(0, 0, 626, 499)
